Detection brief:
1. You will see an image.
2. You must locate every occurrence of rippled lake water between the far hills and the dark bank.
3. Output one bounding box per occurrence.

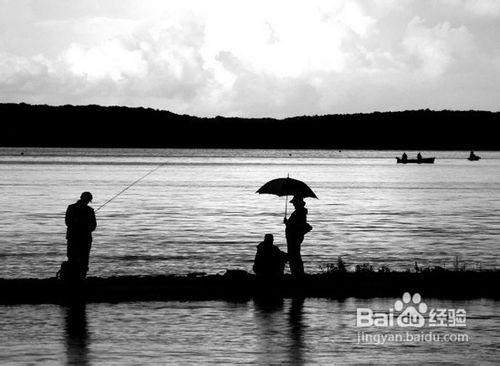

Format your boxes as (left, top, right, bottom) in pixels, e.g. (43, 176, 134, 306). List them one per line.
(0, 148, 500, 278)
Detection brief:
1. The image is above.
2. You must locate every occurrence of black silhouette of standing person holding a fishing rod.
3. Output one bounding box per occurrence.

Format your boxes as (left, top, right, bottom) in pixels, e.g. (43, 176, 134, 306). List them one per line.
(65, 192, 97, 279)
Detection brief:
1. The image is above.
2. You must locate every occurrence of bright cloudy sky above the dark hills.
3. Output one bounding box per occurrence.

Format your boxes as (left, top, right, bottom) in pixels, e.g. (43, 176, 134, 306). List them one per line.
(0, 0, 500, 117)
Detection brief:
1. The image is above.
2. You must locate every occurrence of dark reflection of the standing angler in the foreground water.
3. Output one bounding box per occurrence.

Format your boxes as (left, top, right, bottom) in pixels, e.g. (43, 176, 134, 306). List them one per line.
(63, 303, 90, 365)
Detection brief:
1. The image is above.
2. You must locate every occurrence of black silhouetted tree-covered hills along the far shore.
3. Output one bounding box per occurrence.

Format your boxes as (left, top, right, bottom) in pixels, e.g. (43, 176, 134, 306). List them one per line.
(0, 103, 500, 150)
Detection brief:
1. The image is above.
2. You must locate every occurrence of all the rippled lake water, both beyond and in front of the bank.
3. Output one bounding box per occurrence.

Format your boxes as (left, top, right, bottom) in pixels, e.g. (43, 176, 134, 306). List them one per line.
(0, 148, 500, 364)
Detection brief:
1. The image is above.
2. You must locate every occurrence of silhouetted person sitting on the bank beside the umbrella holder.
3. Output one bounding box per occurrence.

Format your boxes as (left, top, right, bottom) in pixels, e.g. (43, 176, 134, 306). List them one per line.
(253, 234, 287, 278)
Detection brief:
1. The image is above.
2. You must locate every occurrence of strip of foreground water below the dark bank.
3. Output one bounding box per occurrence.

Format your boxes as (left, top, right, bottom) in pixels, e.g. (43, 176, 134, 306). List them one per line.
(0, 298, 500, 365)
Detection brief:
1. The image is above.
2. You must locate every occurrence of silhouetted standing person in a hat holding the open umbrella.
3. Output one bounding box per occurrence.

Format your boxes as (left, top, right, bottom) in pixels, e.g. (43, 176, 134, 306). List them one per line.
(283, 196, 312, 277)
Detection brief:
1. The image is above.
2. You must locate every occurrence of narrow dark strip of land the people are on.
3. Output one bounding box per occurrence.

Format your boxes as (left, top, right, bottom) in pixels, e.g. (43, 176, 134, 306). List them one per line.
(0, 270, 500, 305)
